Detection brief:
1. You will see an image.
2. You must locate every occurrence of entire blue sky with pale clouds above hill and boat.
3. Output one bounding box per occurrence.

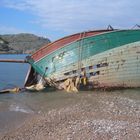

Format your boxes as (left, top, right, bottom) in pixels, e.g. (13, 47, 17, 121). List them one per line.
(0, 0, 140, 41)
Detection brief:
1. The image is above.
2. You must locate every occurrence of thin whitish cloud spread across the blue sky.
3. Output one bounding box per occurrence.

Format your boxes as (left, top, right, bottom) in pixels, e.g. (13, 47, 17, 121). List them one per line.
(3, 0, 140, 33)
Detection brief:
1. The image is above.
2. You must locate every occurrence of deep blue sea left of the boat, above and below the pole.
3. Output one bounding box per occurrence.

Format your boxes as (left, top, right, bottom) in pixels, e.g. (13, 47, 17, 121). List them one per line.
(0, 54, 29, 89)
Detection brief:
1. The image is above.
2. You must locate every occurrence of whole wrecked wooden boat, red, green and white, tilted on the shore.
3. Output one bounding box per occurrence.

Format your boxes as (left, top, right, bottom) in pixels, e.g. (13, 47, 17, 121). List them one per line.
(25, 29, 140, 89)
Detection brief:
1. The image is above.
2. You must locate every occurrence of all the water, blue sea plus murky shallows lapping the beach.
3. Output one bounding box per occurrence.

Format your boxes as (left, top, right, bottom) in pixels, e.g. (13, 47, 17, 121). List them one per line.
(0, 55, 140, 133)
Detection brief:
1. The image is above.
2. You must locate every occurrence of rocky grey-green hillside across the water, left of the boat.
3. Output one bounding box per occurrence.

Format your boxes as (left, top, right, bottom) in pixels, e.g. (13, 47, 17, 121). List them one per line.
(0, 33, 50, 53)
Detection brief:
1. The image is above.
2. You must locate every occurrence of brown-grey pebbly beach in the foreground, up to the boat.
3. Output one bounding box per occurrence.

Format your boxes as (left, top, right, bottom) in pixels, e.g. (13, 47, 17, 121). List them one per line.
(0, 90, 140, 140)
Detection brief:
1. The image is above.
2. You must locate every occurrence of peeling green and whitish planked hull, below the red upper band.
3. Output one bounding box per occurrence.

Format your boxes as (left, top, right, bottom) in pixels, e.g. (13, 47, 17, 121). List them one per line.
(28, 30, 140, 87)
